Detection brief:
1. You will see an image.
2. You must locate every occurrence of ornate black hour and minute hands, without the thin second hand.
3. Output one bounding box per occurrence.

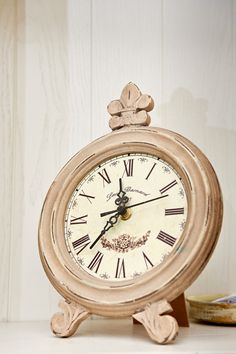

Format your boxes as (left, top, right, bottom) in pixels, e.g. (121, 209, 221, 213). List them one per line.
(90, 178, 129, 249)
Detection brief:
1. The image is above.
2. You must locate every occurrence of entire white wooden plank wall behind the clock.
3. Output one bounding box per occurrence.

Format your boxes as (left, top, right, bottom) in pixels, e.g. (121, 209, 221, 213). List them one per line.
(0, 0, 236, 321)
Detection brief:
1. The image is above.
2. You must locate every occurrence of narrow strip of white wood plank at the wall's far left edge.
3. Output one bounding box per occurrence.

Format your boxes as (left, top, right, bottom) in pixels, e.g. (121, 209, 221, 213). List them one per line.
(0, 0, 16, 321)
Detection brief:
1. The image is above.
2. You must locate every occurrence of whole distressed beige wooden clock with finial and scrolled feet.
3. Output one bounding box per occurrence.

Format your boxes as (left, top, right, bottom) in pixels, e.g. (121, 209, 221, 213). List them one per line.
(39, 83, 223, 343)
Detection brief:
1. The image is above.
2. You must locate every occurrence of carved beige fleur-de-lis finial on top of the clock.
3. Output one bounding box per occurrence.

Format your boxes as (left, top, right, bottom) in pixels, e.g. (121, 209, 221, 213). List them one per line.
(107, 82, 154, 130)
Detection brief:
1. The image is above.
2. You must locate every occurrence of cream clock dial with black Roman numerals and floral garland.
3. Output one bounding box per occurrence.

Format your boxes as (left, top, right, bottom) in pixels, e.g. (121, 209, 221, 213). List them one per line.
(65, 153, 188, 281)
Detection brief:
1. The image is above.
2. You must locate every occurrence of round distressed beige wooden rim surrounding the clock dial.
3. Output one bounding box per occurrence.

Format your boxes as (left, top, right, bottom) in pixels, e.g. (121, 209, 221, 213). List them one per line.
(39, 126, 223, 317)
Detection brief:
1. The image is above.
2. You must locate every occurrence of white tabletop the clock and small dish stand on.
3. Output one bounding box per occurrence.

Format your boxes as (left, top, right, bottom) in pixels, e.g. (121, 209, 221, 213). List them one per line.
(0, 319, 236, 354)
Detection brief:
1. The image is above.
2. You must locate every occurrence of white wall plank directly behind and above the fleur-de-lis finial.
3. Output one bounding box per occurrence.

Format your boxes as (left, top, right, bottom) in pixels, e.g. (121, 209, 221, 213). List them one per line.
(91, 0, 162, 139)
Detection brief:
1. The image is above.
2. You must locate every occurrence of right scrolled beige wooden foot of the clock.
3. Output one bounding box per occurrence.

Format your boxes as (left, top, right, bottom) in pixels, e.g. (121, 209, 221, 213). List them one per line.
(133, 300, 179, 344)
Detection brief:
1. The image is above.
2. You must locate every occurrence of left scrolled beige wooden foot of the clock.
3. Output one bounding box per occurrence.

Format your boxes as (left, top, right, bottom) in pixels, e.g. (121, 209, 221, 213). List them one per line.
(51, 299, 90, 337)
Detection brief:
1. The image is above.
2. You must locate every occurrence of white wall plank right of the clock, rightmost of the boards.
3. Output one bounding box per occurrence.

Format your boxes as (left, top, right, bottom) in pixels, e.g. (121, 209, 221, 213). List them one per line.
(160, 0, 236, 293)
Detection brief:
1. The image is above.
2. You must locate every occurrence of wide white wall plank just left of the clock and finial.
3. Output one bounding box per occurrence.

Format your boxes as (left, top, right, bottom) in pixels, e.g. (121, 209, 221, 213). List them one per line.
(5, 0, 90, 320)
